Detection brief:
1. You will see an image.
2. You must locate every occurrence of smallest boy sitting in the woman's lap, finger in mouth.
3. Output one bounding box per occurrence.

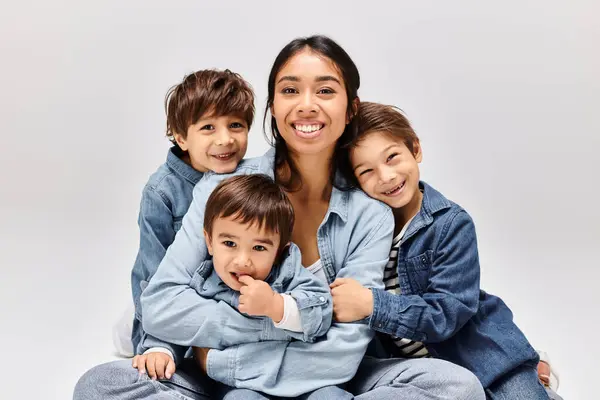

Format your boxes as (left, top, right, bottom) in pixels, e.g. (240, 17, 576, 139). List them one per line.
(184, 174, 342, 399)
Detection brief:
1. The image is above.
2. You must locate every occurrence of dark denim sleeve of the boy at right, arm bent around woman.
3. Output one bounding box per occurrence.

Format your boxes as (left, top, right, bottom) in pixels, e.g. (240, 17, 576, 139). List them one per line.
(370, 210, 479, 342)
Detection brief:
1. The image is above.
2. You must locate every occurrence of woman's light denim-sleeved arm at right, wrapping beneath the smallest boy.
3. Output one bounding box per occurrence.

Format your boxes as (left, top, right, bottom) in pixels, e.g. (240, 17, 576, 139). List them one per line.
(207, 202, 394, 397)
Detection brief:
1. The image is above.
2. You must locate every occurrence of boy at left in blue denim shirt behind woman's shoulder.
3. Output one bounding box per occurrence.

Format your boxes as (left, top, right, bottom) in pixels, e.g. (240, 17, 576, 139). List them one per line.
(114, 70, 254, 382)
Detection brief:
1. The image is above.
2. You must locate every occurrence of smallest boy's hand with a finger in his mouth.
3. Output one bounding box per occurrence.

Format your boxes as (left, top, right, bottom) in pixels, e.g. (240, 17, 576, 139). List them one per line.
(238, 275, 283, 322)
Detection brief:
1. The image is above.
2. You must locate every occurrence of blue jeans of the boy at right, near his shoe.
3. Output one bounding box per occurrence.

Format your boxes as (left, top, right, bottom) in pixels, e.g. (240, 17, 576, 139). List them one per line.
(485, 365, 550, 400)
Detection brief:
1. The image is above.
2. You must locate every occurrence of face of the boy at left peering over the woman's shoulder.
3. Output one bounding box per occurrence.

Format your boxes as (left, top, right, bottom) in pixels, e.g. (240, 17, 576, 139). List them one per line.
(175, 115, 248, 173)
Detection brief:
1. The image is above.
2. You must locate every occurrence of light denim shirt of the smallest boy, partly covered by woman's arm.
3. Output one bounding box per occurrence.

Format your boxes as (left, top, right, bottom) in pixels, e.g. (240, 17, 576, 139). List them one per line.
(190, 244, 333, 349)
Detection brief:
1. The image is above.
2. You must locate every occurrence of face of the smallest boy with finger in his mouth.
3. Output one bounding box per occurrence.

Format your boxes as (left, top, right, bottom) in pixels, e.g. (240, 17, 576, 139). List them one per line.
(204, 216, 280, 291)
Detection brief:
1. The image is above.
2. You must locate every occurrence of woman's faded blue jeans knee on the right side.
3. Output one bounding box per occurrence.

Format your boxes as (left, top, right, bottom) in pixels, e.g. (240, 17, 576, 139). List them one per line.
(348, 357, 485, 400)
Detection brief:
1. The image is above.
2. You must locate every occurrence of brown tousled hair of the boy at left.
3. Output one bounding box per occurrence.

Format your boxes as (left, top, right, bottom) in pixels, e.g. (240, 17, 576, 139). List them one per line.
(165, 69, 254, 144)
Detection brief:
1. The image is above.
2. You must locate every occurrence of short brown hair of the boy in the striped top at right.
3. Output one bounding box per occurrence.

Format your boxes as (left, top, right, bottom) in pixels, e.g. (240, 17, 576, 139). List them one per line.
(339, 101, 419, 187)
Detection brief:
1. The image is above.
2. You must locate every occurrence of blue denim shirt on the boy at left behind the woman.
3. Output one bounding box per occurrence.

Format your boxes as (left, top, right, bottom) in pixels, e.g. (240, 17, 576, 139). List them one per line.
(131, 146, 203, 354)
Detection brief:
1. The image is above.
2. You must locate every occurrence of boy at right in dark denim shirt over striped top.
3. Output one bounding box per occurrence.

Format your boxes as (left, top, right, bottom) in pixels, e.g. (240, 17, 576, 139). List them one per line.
(332, 103, 560, 400)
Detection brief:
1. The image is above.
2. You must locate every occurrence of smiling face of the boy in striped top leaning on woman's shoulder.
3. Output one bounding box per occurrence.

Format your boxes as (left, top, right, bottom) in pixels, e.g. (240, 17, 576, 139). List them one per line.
(350, 132, 422, 208)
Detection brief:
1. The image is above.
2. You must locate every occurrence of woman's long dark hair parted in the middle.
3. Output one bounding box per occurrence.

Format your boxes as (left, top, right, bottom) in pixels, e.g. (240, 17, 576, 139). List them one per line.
(263, 35, 360, 191)
